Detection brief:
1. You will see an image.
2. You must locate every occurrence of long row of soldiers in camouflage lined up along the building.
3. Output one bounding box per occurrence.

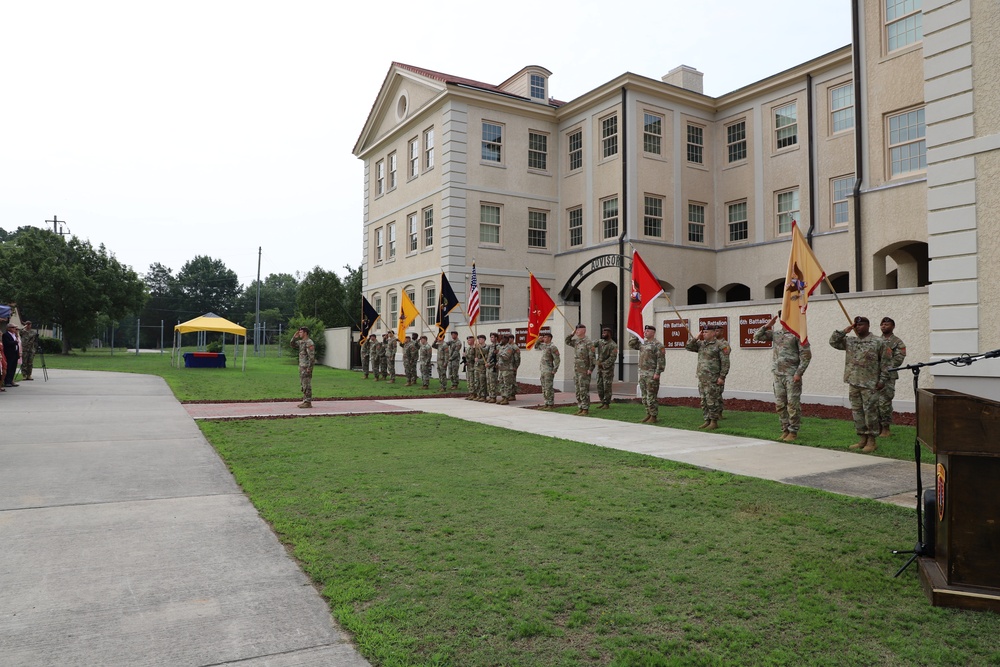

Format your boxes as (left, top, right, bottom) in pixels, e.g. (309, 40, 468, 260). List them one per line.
(361, 312, 906, 453)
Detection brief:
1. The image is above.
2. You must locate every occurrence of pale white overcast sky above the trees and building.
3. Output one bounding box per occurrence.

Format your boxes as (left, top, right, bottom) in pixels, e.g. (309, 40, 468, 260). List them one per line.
(0, 0, 851, 285)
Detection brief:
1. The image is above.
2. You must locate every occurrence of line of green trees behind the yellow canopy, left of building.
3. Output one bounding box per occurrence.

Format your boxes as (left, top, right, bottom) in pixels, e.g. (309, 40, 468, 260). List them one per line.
(0, 227, 361, 352)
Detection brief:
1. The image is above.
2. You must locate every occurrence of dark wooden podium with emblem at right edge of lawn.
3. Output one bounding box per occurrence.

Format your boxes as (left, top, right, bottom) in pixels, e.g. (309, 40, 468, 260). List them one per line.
(917, 389, 1000, 612)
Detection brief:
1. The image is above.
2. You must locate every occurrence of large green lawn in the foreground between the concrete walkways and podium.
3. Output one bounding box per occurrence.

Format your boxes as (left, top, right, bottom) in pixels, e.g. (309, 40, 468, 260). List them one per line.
(201, 418, 1000, 667)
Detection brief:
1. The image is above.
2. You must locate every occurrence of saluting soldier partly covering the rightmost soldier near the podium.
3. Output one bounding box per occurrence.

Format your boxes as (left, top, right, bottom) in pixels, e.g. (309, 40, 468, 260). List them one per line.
(830, 317, 892, 454)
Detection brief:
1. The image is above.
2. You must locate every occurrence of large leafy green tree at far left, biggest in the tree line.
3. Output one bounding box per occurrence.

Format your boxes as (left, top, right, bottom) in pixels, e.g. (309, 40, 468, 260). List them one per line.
(0, 227, 146, 352)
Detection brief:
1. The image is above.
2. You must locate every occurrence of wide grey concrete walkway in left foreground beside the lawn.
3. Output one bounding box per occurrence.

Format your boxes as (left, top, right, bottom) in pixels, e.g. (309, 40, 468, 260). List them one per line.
(0, 370, 368, 667)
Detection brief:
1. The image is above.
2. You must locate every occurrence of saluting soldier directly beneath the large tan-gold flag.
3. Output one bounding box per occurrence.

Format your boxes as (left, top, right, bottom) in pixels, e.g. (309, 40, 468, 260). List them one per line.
(753, 311, 812, 442)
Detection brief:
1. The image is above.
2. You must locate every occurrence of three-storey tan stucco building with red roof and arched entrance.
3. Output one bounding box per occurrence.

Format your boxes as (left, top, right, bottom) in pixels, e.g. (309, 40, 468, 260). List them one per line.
(354, 0, 1000, 409)
